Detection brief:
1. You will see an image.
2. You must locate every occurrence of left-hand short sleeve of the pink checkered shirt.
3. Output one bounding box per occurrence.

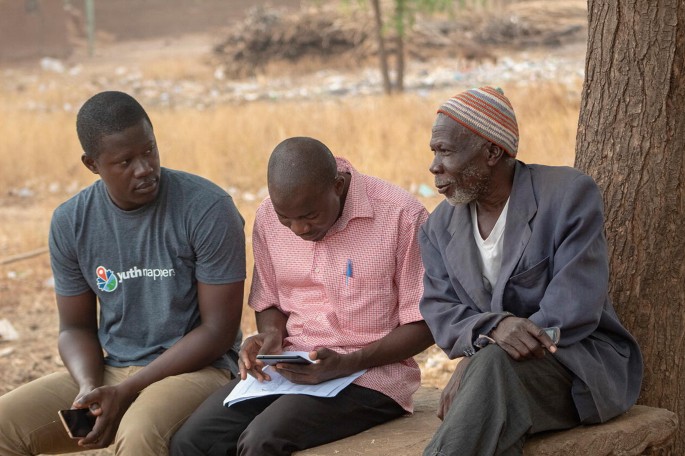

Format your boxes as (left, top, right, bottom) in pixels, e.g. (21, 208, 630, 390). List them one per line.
(248, 200, 278, 312)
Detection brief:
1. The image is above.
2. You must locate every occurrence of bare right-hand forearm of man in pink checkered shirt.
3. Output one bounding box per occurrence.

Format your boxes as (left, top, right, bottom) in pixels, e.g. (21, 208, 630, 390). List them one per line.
(345, 321, 433, 372)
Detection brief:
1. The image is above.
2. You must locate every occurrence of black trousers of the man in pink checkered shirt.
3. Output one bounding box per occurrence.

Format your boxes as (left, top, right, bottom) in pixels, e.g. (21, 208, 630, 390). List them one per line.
(169, 380, 405, 456)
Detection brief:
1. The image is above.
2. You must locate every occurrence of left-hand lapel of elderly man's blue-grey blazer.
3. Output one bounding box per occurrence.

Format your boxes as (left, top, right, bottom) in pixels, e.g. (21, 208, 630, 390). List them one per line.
(446, 204, 491, 312)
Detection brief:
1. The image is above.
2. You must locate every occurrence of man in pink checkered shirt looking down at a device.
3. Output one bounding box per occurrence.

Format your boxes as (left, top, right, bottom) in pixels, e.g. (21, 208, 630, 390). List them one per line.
(171, 137, 433, 456)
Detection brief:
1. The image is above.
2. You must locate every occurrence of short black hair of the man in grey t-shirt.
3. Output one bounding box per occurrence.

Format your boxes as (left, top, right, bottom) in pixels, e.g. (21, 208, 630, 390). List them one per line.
(76, 91, 152, 158)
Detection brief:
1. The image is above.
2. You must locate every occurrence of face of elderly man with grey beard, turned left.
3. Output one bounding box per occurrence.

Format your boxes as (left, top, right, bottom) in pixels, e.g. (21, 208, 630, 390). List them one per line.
(429, 114, 491, 205)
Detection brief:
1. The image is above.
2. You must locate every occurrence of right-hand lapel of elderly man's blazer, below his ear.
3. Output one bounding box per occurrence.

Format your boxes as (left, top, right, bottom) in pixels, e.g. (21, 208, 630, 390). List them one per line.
(492, 161, 538, 312)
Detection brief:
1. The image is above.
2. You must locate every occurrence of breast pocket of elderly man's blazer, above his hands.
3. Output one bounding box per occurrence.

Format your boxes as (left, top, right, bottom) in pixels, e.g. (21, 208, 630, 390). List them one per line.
(504, 257, 551, 317)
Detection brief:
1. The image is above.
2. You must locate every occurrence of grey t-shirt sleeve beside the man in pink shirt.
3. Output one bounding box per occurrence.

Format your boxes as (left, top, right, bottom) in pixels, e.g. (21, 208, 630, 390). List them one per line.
(191, 195, 245, 285)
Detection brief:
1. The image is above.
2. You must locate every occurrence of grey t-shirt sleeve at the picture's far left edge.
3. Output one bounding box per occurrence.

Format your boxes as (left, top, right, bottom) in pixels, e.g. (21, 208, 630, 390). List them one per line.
(48, 209, 90, 296)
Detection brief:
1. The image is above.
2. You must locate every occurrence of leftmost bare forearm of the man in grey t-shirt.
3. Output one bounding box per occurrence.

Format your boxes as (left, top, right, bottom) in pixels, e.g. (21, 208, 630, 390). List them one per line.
(58, 329, 104, 392)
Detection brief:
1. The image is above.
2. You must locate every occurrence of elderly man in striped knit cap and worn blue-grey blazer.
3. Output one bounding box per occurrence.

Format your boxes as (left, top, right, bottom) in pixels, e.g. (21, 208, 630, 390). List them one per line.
(419, 87, 642, 456)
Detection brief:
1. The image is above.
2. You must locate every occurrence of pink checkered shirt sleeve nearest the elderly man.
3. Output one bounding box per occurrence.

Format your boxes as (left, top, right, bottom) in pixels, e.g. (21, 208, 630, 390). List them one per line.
(395, 202, 428, 325)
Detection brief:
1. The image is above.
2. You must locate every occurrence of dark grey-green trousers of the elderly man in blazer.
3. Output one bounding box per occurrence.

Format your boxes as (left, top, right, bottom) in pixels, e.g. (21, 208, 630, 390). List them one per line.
(424, 345, 580, 456)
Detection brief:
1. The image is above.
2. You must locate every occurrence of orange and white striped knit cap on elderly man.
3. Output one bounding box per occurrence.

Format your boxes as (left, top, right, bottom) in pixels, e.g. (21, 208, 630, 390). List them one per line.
(438, 87, 519, 157)
